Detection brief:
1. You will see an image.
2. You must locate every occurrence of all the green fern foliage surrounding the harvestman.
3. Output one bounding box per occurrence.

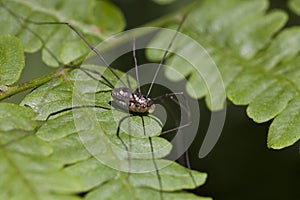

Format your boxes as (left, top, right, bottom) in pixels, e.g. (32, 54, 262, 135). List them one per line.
(0, 0, 300, 199)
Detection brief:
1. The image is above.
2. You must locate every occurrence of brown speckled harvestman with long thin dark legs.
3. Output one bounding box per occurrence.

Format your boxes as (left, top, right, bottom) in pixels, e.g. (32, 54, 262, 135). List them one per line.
(1, 1, 196, 199)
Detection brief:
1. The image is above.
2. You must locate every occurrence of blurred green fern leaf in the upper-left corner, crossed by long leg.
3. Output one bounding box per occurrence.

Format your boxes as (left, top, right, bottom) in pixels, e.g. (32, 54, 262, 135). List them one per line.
(0, 0, 124, 66)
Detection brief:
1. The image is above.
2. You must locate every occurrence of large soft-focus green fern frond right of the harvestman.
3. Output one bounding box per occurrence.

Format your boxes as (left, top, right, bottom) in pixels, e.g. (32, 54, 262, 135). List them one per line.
(148, 0, 300, 148)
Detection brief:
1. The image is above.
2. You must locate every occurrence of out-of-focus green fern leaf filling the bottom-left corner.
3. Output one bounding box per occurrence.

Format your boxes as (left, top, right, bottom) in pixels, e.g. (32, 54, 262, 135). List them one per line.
(0, 103, 80, 199)
